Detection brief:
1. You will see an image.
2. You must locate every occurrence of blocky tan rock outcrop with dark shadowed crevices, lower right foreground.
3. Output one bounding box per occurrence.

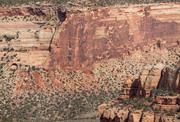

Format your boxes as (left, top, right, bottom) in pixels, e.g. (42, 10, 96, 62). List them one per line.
(98, 64, 180, 122)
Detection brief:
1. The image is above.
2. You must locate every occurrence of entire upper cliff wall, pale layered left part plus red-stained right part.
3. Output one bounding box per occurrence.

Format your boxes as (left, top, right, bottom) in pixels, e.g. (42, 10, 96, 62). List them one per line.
(0, 4, 180, 70)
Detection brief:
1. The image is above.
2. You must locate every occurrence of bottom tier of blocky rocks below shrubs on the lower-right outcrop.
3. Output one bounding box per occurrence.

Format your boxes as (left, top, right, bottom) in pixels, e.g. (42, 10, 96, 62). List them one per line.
(98, 96, 179, 122)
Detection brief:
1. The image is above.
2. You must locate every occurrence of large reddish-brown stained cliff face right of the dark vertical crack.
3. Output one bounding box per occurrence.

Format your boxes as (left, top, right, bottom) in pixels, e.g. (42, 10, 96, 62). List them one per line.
(53, 4, 180, 69)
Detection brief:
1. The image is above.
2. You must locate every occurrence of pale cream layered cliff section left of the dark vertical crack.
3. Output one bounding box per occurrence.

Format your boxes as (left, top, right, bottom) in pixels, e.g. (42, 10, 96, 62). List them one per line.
(0, 6, 61, 68)
